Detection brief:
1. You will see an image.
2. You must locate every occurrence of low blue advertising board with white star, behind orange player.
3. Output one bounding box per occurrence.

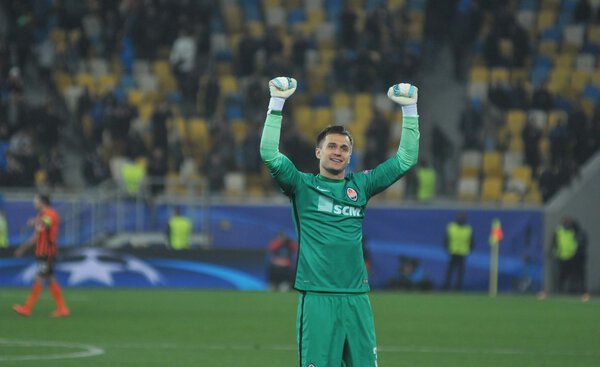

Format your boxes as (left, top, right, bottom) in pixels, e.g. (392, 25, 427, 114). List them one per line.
(0, 246, 266, 290)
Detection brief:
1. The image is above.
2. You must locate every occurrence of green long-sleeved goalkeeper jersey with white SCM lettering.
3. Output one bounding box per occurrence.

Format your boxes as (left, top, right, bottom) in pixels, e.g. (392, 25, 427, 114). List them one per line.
(260, 111, 419, 293)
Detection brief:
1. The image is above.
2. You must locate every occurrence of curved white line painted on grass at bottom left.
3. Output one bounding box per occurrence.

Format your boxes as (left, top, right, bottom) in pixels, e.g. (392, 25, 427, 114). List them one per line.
(0, 339, 104, 363)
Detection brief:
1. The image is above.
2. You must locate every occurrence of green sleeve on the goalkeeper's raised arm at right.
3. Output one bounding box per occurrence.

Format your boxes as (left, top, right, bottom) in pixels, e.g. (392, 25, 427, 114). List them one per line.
(367, 116, 420, 196)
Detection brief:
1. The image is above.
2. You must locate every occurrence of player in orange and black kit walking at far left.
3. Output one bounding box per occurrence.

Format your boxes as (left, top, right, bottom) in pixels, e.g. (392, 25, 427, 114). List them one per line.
(13, 194, 69, 317)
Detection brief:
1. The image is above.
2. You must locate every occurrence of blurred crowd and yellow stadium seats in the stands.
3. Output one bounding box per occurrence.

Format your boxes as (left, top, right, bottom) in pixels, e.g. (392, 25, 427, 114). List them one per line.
(0, 0, 600, 205)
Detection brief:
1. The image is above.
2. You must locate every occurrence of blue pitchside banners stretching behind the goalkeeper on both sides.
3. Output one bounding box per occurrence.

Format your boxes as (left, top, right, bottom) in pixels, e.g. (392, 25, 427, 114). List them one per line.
(0, 201, 543, 292)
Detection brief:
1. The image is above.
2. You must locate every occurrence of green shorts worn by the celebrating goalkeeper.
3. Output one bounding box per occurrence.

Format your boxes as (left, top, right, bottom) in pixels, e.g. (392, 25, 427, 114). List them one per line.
(296, 292, 377, 367)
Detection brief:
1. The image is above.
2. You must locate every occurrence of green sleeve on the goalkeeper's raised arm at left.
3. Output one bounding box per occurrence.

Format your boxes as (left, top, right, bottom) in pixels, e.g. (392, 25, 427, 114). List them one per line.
(260, 111, 300, 195)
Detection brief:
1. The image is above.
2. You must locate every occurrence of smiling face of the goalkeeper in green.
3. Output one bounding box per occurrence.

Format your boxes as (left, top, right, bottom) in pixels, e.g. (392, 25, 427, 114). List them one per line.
(315, 134, 352, 179)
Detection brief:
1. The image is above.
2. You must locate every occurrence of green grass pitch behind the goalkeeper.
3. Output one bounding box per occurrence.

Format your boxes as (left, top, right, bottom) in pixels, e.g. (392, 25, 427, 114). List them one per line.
(0, 289, 600, 367)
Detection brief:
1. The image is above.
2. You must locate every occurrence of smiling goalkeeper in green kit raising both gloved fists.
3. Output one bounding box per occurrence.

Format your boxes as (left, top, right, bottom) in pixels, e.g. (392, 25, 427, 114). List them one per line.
(260, 77, 419, 367)
